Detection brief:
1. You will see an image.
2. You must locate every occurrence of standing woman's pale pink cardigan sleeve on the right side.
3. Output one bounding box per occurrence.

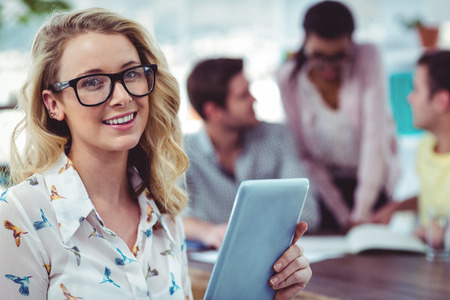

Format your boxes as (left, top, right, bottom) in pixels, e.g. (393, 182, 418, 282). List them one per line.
(352, 45, 396, 221)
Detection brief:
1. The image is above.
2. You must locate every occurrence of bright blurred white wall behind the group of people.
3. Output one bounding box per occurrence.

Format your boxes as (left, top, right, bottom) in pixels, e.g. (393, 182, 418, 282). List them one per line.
(0, 0, 450, 120)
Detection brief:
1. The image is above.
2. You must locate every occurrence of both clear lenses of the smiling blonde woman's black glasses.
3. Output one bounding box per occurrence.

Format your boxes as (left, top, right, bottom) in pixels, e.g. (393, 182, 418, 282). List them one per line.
(76, 66, 154, 105)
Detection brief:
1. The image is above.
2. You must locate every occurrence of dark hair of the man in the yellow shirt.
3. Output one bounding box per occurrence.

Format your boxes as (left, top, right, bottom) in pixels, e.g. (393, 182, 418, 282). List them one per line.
(417, 50, 450, 97)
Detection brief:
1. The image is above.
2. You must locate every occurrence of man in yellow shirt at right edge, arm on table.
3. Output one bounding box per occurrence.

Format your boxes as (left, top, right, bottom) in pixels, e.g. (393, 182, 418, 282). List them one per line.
(372, 50, 450, 238)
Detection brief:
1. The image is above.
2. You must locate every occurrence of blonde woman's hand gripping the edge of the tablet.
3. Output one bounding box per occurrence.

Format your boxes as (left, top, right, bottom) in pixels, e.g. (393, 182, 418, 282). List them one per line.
(269, 222, 312, 300)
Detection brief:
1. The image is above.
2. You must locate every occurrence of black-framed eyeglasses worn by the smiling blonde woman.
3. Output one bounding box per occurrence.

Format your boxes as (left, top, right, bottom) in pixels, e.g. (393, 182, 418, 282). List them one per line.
(50, 64, 158, 106)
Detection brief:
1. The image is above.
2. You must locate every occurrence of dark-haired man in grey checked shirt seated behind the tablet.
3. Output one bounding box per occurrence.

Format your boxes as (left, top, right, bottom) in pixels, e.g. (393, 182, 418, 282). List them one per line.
(184, 58, 320, 248)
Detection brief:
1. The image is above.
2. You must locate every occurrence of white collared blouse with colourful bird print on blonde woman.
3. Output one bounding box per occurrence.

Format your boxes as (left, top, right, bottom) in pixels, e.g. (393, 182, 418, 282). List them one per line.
(0, 154, 193, 300)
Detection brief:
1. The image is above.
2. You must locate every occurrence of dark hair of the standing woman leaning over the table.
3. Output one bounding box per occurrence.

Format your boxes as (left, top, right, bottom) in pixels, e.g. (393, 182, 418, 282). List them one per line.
(292, 1, 355, 77)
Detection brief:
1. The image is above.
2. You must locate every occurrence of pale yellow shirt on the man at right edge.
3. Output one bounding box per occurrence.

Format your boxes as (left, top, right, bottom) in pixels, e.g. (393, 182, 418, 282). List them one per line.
(417, 134, 450, 225)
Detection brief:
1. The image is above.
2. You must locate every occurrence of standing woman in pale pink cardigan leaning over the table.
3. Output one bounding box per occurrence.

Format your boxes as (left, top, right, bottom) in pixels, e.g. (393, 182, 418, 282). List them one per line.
(277, 1, 399, 231)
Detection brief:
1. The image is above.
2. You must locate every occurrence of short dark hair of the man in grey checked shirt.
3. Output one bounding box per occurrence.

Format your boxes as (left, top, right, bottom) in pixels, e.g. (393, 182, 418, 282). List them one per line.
(187, 58, 244, 120)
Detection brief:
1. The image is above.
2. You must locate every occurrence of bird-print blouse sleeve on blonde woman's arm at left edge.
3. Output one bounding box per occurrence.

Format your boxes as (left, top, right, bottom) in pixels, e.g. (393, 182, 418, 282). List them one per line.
(0, 190, 50, 299)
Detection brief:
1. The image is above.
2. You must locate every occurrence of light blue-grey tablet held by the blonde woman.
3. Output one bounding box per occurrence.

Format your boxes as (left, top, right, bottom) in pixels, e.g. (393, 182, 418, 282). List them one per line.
(204, 178, 309, 300)
